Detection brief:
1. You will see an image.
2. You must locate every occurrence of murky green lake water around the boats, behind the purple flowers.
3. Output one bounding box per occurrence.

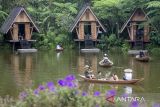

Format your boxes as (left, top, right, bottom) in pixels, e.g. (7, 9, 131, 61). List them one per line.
(0, 50, 160, 103)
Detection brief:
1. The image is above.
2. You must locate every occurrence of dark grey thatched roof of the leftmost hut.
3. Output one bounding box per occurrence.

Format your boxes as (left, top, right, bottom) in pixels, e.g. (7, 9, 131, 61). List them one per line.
(0, 7, 39, 34)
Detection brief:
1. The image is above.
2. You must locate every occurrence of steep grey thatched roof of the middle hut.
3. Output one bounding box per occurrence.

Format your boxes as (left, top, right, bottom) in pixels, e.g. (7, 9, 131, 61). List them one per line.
(69, 5, 106, 32)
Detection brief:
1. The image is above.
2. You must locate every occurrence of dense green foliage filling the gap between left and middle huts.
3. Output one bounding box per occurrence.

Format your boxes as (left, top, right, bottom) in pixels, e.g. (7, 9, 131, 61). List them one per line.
(23, 0, 77, 49)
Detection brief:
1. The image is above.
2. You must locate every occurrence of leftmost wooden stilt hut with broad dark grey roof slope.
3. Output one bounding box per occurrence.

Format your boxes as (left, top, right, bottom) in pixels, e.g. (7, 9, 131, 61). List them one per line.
(0, 7, 39, 50)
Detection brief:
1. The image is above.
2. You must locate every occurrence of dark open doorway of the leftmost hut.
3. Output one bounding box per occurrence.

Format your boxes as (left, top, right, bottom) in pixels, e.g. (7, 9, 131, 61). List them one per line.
(18, 24, 25, 40)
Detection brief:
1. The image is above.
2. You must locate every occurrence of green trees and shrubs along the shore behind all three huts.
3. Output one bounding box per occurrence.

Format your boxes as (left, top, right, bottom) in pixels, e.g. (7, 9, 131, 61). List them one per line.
(0, 0, 160, 53)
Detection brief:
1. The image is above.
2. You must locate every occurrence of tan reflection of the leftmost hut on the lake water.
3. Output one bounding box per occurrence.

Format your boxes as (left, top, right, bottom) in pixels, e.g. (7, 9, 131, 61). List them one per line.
(10, 54, 33, 87)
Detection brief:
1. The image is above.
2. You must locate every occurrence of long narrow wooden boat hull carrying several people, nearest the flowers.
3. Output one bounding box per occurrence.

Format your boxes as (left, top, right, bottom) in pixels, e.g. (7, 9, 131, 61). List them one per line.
(79, 75, 144, 84)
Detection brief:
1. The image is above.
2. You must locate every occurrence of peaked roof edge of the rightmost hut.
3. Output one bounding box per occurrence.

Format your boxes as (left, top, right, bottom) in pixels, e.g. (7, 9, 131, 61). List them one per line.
(120, 8, 149, 33)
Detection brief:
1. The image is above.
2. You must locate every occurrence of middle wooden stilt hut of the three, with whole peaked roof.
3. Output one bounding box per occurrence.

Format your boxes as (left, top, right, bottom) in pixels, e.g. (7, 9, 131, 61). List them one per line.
(69, 4, 106, 49)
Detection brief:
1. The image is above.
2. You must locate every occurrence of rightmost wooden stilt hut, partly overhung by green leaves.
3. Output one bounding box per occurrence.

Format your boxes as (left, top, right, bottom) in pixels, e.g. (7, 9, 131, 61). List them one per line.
(120, 8, 150, 49)
